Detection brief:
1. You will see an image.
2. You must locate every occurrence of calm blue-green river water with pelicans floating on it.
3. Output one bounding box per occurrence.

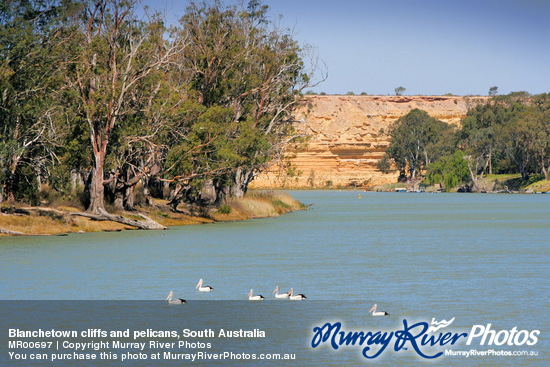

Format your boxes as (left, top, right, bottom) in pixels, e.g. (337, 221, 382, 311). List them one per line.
(0, 191, 550, 366)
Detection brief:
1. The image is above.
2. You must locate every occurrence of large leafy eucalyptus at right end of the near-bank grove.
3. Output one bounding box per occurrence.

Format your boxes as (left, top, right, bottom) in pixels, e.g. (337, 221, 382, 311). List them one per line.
(169, 0, 322, 208)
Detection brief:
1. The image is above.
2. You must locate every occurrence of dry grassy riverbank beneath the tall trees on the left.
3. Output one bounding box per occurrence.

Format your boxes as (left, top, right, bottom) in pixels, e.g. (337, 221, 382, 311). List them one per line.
(0, 192, 306, 237)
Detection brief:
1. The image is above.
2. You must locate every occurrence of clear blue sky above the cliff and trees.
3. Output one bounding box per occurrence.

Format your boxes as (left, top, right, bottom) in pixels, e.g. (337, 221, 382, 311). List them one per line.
(146, 0, 550, 95)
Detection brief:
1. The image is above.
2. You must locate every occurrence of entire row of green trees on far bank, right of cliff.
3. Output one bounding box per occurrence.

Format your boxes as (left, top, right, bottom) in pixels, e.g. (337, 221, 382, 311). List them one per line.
(378, 92, 550, 191)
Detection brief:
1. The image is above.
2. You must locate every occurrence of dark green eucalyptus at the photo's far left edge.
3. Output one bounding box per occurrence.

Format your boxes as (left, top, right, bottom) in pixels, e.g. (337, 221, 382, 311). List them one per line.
(0, 0, 70, 204)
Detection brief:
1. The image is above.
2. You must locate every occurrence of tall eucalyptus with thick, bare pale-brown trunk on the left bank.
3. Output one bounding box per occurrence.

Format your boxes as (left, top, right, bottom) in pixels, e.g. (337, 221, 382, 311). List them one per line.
(64, 0, 183, 213)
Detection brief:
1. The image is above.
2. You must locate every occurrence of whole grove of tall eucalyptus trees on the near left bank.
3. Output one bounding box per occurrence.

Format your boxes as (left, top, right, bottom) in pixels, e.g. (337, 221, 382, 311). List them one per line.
(0, 0, 324, 213)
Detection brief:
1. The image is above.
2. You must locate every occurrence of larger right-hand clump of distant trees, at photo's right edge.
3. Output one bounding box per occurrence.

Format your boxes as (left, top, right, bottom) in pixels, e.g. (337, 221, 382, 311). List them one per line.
(459, 92, 550, 183)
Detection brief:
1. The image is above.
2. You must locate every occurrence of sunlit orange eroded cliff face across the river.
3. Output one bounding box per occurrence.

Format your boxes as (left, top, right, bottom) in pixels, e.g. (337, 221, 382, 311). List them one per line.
(251, 96, 487, 188)
